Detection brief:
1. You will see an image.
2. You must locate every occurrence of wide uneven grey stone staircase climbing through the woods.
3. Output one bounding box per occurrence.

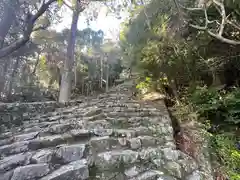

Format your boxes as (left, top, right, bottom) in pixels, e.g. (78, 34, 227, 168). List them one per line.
(0, 83, 214, 180)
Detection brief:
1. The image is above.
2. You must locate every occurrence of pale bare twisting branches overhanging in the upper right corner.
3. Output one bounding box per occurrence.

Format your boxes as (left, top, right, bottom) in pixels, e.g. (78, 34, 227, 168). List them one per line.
(174, 0, 240, 45)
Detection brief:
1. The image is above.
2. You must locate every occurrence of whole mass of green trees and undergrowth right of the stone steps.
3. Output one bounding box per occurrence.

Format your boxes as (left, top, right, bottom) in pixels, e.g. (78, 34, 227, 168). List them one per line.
(120, 0, 240, 180)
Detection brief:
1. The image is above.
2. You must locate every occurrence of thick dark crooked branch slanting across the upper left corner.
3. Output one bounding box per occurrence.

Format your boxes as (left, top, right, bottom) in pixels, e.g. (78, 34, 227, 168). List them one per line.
(0, 0, 56, 58)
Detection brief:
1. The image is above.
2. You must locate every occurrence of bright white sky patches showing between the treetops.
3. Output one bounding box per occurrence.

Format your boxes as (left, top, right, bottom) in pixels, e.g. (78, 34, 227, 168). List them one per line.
(54, 5, 126, 41)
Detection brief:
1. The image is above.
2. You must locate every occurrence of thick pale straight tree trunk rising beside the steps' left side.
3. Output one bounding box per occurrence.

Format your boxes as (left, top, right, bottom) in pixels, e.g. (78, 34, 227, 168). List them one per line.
(59, 10, 79, 102)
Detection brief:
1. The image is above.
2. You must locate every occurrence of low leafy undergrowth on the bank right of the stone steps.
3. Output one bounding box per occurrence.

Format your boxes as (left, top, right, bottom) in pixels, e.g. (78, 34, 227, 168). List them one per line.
(174, 87, 240, 180)
